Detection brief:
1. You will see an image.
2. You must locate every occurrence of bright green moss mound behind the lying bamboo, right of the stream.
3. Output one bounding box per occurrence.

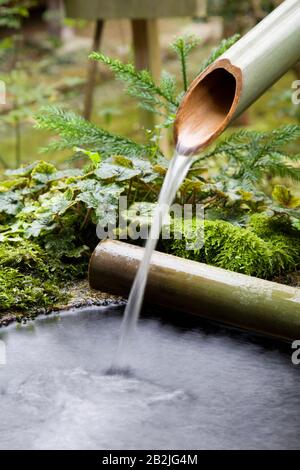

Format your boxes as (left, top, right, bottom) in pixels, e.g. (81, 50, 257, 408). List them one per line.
(169, 218, 300, 279)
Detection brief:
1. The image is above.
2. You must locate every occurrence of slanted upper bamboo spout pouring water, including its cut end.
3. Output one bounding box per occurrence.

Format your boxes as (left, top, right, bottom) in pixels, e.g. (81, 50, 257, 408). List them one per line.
(174, 0, 300, 154)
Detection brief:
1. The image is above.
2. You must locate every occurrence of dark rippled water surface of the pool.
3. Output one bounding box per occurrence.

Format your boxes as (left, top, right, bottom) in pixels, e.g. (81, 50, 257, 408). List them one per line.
(0, 309, 300, 449)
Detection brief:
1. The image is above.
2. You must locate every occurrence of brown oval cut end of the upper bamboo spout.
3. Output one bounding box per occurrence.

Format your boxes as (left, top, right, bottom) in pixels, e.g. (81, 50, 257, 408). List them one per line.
(174, 59, 242, 155)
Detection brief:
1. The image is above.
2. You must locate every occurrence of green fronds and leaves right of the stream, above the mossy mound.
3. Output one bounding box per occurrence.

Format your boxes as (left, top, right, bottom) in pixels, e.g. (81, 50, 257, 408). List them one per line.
(200, 125, 300, 218)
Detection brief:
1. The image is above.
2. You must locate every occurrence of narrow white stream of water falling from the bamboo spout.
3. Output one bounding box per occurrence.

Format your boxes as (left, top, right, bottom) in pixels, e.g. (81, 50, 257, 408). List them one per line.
(112, 147, 193, 371)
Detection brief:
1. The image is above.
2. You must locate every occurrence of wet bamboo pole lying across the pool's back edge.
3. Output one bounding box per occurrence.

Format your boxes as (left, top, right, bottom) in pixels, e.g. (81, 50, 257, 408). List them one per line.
(89, 240, 300, 340)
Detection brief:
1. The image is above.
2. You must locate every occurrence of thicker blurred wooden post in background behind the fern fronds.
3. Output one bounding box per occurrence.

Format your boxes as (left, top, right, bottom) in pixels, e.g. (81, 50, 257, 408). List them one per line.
(131, 19, 169, 154)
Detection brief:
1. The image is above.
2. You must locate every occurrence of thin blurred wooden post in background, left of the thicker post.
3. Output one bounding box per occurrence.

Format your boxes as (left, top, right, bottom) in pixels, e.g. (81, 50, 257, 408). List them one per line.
(83, 20, 104, 119)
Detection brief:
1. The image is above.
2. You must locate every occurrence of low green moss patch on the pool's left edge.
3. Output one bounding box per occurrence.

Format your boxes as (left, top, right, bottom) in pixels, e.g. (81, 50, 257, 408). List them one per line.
(0, 240, 87, 315)
